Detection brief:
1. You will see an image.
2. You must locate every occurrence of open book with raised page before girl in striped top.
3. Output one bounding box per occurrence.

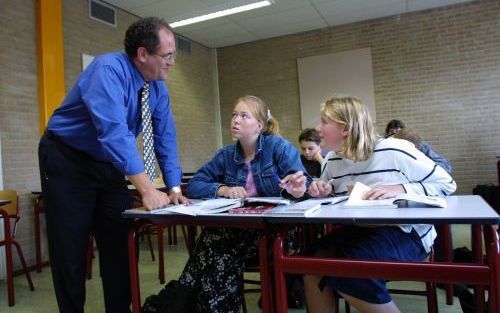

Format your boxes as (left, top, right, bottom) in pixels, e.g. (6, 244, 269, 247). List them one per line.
(344, 182, 447, 209)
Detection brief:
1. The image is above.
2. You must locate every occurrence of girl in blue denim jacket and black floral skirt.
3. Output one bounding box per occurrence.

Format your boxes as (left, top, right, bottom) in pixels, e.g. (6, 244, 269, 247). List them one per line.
(146, 96, 311, 313)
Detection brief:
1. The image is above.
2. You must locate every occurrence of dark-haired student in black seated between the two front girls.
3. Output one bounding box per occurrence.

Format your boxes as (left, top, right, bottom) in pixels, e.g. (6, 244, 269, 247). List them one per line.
(299, 128, 323, 178)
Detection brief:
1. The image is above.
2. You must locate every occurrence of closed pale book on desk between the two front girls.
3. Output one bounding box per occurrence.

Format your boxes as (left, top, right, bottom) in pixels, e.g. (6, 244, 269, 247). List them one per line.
(264, 196, 347, 217)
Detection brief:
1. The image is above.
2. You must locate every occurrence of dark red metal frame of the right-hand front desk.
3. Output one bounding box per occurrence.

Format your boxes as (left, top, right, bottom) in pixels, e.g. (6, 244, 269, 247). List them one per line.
(274, 224, 500, 313)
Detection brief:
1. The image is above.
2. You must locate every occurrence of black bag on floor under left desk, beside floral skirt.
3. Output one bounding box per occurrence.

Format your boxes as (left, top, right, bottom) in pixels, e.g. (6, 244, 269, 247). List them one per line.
(141, 280, 201, 313)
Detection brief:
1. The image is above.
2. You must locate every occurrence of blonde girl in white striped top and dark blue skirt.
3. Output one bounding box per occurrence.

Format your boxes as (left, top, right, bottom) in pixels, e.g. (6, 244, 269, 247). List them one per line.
(304, 96, 456, 313)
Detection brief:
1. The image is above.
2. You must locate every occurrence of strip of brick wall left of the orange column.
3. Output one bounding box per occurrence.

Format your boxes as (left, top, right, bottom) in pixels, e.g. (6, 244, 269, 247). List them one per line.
(0, 0, 40, 268)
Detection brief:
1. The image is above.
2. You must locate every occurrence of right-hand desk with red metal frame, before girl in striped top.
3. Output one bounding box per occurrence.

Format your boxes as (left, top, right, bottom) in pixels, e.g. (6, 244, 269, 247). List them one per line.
(266, 196, 500, 313)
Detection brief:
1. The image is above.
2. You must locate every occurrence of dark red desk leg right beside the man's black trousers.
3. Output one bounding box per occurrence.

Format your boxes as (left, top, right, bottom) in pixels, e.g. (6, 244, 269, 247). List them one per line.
(128, 222, 143, 313)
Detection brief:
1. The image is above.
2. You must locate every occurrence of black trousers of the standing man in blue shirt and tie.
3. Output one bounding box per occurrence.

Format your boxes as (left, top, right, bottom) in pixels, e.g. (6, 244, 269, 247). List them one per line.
(38, 132, 131, 313)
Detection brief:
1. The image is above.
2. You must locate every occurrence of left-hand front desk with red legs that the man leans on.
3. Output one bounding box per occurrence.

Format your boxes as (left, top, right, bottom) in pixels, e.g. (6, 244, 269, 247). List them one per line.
(122, 210, 274, 313)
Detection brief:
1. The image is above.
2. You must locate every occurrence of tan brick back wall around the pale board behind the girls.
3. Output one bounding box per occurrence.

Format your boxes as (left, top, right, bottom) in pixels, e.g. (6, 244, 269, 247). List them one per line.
(218, 0, 500, 194)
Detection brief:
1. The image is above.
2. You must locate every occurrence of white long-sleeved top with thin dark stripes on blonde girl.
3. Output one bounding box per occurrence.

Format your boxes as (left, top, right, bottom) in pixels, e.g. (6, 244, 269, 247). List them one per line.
(321, 138, 457, 252)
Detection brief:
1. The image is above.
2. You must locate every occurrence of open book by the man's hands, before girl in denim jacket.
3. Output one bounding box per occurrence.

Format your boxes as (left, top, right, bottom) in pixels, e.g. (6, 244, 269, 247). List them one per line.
(145, 197, 290, 216)
